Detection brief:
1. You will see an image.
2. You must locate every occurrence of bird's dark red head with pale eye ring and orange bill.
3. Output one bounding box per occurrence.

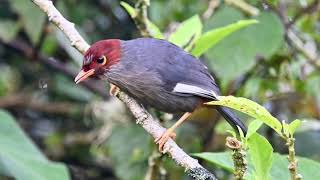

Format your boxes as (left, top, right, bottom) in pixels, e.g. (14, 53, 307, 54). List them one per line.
(74, 39, 121, 84)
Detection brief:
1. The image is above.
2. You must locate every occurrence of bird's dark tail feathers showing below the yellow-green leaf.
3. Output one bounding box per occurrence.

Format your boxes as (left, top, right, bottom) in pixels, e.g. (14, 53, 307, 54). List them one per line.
(216, 106, 247, 134)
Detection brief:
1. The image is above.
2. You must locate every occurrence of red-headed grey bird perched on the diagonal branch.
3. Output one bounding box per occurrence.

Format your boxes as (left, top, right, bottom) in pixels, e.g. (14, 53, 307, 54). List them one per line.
(75, 38, 247, 151)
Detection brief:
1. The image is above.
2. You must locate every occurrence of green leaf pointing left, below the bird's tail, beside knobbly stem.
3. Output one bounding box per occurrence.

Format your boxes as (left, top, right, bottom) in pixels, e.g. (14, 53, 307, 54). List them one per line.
(192, 152, 234, 172)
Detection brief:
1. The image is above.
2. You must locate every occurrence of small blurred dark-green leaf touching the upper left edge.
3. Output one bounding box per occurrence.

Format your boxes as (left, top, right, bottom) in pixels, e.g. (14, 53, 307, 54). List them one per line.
(0, 20, 20, 42)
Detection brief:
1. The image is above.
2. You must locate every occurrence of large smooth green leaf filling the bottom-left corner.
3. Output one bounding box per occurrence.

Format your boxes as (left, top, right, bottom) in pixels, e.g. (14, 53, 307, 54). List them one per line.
(0, 110, 70, 180)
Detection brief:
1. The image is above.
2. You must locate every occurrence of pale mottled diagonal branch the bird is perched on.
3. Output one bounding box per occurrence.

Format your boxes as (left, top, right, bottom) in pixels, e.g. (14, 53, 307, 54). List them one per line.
(32, 0, 216, 179)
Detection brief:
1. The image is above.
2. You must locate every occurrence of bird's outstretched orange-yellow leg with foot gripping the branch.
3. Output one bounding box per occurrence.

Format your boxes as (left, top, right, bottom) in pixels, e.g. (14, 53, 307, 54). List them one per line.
(155, 112, 191, 152)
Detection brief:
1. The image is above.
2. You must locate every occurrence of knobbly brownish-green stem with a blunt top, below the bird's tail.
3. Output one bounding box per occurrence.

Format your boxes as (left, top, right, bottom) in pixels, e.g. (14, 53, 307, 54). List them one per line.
(226, 137, 247, 180)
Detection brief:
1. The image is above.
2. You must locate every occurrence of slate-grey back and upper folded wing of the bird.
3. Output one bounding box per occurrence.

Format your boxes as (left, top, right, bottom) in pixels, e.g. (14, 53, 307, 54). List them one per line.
(124, 38, 220, 99)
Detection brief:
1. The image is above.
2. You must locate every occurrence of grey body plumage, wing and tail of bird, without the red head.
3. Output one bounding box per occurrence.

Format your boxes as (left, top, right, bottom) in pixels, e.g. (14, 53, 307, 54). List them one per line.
(105, 38, 245, 131)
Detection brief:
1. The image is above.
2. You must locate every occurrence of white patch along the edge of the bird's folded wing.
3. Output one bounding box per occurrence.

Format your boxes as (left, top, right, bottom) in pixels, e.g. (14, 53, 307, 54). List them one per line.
(172, 83, 217, 100)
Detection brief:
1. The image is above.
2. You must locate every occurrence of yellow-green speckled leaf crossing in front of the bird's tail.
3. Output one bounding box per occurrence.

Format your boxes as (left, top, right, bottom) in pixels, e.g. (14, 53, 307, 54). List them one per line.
(207, 96, 282, 134)
